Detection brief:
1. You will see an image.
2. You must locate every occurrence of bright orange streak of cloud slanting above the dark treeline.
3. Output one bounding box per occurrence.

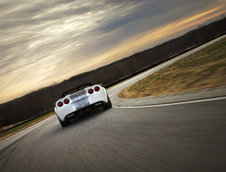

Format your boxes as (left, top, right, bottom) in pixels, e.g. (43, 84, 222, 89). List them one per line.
(89, 5, 225, 67)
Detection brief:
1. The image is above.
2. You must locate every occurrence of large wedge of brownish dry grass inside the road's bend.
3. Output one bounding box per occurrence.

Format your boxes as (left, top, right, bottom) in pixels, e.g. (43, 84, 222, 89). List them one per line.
(119, 38, 226, 98)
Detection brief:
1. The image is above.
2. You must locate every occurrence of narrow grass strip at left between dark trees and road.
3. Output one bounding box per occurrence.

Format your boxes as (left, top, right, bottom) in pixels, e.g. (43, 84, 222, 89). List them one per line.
(0, 112, 55, 141)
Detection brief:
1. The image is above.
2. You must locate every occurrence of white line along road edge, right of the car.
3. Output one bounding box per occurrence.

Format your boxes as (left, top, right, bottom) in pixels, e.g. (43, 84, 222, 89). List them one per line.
(113, 96, 226, 109)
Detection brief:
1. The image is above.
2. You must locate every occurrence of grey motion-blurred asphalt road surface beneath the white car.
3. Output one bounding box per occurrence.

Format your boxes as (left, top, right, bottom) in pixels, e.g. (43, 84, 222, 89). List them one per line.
(0, 99, 226, 172)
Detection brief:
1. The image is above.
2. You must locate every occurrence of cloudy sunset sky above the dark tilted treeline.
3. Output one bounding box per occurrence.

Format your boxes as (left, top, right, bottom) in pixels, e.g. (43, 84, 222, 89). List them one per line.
(0, 0, 226, 103)
